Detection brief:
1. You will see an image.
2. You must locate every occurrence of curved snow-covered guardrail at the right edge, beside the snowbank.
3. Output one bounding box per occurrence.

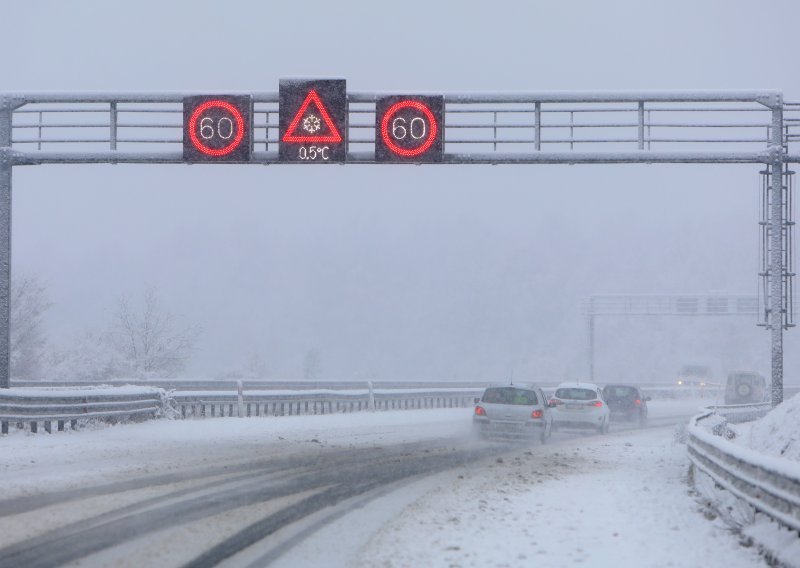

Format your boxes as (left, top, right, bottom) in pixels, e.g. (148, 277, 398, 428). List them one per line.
(687, 411, 800, 530)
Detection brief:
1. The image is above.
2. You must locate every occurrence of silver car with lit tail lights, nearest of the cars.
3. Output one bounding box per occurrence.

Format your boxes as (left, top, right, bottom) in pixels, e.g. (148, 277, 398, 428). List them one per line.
(472, 385, 553, 443)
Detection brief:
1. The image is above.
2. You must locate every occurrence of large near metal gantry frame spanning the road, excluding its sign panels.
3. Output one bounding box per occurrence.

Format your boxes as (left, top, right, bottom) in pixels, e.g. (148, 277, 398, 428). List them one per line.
(0, 91, 800, 404)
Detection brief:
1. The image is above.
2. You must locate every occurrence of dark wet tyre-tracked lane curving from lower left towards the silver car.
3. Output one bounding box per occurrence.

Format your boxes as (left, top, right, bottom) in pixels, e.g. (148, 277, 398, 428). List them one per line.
(0, 439, 503, 567)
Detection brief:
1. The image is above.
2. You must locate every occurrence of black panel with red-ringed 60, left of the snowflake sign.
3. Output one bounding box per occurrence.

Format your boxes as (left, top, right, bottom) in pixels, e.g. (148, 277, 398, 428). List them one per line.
(183, 95, 253, 162)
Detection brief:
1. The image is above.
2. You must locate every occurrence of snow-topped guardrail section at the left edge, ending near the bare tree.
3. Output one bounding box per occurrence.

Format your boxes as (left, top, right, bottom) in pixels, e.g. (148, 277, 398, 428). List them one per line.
(0, 387, 165, 434)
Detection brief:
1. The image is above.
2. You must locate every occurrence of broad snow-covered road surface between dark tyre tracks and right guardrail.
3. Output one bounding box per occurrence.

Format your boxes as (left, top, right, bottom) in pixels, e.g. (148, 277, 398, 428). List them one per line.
(276, 418, 766, 568)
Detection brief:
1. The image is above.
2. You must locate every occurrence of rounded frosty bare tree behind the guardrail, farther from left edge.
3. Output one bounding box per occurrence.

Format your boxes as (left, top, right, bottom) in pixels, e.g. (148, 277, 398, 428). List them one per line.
(109, 287, 200, 377)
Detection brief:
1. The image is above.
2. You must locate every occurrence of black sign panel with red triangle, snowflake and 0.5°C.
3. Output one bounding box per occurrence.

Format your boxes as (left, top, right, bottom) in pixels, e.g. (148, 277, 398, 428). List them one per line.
(278, 79, 347, 164)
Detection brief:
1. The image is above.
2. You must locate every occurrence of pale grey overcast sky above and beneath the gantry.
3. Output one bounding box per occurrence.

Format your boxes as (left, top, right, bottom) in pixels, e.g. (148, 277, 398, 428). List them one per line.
(0, 0, 800, 382)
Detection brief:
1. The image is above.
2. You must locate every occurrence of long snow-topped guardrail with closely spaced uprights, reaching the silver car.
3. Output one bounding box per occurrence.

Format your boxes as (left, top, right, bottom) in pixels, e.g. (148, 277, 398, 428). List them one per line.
(171, 388, 483, 418)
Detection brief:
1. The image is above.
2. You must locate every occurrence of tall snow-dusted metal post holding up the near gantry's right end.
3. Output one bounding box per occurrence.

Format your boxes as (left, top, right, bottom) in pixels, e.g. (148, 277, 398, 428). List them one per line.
(769, 104, 785, 407)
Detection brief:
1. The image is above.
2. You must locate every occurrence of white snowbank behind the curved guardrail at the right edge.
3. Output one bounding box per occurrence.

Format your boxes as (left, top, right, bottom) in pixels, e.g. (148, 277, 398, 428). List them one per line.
(733, 394, 800, 461)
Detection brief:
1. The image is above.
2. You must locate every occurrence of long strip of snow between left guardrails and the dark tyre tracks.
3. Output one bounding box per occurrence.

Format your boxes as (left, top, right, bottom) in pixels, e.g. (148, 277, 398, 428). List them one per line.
(0, 408, 471, 498)
